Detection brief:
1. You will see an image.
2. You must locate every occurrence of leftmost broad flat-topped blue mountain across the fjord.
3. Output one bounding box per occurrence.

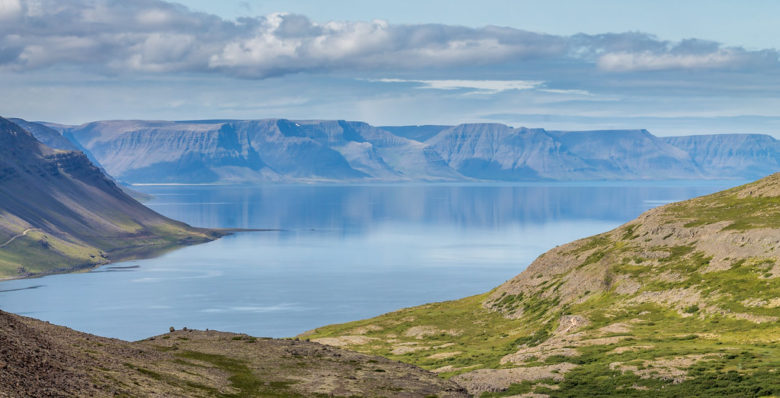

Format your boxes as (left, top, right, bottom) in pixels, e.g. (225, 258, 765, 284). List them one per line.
(48, 119, 452, 183)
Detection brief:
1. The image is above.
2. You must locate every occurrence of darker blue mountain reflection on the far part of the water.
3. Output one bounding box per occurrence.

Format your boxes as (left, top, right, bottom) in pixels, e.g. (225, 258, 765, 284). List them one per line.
(141, 182, 736, 233)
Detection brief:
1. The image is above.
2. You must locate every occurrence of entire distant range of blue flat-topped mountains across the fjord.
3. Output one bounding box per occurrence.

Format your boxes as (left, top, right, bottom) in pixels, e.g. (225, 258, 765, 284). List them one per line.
(15, 119, 780, 183)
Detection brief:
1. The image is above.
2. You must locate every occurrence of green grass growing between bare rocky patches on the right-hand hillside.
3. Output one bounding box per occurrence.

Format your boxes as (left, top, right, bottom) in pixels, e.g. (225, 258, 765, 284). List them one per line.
(308, 178, 780, 397)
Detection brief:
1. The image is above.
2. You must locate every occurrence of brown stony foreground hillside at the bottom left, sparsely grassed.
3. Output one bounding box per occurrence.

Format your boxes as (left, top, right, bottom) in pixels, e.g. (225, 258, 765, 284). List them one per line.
(0, 311, 466, 398)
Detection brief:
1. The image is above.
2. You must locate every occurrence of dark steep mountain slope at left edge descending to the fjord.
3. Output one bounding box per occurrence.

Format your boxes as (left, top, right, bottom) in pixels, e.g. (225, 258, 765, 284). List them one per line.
(0, 118, 221, 278)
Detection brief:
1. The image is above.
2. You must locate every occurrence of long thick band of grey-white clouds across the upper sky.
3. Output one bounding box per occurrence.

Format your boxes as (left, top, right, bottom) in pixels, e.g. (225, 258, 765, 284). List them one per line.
(0, 0, 778, 78)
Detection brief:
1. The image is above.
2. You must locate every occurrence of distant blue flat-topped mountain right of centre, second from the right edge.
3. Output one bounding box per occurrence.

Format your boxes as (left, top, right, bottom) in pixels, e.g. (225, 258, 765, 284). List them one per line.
(426, 124, 702, 180)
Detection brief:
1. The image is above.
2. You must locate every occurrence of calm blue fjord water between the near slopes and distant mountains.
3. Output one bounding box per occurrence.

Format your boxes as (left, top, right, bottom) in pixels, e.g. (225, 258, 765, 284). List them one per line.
(0, 181, 738, 340)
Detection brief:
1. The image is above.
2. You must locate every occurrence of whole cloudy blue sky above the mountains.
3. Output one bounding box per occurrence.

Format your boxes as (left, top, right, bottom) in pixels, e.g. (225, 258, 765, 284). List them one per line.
(0, 0, 780, 138)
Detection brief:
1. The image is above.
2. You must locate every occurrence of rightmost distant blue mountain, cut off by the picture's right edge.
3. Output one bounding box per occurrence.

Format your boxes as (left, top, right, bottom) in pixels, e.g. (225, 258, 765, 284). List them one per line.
(663, 134, 780, 179)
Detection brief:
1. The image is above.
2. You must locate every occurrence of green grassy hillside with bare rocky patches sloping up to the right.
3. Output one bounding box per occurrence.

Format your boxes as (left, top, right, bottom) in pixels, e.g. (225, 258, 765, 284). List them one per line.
(306, 173, 780, 397)
